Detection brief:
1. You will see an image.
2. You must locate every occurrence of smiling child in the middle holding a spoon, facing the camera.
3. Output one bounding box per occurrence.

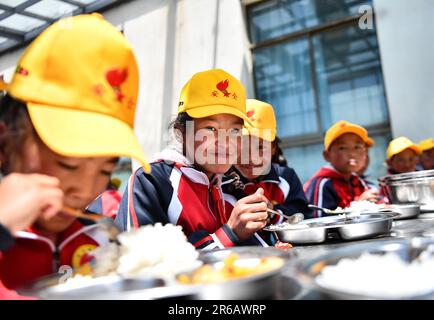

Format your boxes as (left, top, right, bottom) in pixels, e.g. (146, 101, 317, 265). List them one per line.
(116, 69, 268, 249)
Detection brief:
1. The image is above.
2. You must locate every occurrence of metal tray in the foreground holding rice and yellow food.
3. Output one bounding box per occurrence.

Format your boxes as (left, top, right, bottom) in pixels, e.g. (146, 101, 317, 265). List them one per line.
(20, 247, 292, 300)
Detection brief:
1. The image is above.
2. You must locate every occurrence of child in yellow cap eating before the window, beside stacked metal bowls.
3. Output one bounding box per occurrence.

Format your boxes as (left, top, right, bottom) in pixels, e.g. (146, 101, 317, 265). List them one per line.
(304, 121, 380, 216)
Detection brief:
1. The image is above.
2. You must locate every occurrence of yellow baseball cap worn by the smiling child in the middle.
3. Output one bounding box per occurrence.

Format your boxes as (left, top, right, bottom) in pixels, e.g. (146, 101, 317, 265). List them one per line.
(178, 69, 250, 123)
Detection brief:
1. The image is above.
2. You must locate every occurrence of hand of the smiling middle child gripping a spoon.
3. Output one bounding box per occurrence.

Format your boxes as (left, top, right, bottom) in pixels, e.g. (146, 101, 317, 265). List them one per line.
(228, 188, 268, 240)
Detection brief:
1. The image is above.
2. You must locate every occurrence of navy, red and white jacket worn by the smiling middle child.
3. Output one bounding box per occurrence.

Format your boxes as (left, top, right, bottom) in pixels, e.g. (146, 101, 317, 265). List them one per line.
(116, 151, 261, 250)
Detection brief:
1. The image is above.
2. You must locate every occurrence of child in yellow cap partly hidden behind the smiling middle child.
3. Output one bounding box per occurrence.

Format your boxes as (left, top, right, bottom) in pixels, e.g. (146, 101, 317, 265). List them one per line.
(223, 99, 308, 243)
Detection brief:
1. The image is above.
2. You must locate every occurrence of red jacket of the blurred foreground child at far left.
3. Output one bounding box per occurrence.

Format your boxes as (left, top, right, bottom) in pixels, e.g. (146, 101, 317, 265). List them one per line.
(0, 219, 108, 289)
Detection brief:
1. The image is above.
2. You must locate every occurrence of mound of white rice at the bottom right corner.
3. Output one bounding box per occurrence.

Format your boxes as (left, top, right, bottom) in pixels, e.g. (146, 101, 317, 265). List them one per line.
(316, 252, 434, 299)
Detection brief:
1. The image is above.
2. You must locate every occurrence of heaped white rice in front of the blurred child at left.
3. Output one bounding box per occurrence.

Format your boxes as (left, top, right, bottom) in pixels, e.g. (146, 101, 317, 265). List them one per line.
(69, 223, 202, 281)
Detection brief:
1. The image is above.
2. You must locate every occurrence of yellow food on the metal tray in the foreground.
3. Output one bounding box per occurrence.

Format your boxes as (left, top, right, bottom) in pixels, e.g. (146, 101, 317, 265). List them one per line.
(178, 253, 283, 284)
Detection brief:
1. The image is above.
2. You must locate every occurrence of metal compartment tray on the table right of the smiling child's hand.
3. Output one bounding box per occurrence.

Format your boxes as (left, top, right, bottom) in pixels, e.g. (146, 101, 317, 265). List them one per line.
(264, 212, 399, 244)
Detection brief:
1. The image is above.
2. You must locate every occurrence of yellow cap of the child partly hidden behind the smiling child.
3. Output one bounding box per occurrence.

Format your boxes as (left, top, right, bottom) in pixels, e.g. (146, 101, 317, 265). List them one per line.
(243, 99, 277, 142)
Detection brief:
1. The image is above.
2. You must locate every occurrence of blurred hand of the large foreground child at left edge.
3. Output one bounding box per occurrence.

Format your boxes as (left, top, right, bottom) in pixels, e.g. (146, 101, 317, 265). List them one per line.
(0, 173, 63, 234)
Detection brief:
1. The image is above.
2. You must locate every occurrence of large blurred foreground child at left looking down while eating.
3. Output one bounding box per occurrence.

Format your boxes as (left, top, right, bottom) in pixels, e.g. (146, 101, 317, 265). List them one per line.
(0, 14, 149, 288)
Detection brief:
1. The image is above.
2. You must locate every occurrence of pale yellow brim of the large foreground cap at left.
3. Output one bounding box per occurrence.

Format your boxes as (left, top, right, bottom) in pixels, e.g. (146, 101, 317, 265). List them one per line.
(27, 102, 151, 173)
